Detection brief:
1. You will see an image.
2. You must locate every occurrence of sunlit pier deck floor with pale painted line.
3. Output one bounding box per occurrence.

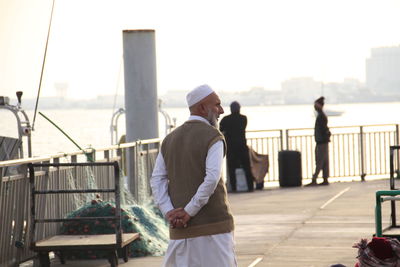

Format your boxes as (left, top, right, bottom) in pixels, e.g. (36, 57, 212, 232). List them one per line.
(47, 179, 390, 267)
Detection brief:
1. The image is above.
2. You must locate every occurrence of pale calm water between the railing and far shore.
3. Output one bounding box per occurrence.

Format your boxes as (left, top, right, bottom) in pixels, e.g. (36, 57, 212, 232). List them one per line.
(0, 102, 400, 156)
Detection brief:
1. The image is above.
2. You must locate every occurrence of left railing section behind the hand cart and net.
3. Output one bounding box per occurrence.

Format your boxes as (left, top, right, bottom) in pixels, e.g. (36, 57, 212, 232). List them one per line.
(0, 139, 160, 267)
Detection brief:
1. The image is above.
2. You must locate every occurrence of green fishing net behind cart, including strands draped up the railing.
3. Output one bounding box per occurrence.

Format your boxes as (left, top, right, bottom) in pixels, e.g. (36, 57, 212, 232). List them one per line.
(61, 160, 169, 259)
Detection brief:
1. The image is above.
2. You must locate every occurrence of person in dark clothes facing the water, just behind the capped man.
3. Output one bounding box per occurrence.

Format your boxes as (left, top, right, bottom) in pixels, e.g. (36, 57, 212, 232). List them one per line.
(219, 101, 254, 192)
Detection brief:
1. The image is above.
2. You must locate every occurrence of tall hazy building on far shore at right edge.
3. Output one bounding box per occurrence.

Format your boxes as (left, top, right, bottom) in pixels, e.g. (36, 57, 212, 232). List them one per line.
(366, 46, 400, 95)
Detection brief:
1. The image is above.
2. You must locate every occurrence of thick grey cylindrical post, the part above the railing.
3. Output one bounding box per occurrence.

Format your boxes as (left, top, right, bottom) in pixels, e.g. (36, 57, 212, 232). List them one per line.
(123, 30, 158, 142)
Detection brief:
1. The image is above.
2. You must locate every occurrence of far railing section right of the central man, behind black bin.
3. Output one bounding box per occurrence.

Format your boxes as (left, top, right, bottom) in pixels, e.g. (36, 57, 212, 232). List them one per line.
(247, 124, 399, 182)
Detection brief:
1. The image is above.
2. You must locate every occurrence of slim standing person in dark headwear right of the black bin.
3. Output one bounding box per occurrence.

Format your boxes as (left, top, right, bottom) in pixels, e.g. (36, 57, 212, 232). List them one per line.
(308, 96, 331, 186)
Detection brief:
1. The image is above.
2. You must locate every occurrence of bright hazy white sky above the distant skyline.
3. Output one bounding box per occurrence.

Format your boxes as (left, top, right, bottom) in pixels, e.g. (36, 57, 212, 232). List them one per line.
(0, 0, 400, 98)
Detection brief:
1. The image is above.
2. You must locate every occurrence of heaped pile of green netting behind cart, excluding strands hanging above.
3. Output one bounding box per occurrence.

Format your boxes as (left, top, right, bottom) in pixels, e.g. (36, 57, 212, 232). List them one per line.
(61, 196, 168, 259)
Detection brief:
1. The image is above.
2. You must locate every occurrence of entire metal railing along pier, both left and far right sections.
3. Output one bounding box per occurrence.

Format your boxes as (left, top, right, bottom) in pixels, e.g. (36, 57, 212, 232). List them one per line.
(0, 124, 399, 266)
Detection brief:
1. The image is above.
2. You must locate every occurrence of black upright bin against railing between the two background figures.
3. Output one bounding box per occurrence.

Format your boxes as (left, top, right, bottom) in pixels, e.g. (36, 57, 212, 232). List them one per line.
(278, 150, 302, 187)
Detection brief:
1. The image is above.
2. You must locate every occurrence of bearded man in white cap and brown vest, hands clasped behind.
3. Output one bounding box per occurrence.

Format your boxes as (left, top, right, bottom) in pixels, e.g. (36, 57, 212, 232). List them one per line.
(150, 85, 237, 267)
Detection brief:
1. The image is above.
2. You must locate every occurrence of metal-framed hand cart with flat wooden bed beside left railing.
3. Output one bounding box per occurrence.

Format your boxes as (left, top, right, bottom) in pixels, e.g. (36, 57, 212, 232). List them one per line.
(28, 162, 139, 267)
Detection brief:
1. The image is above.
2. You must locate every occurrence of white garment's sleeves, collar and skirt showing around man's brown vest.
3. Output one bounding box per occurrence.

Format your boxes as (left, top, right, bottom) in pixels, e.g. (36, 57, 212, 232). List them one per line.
(150, 115, 237, 267)
